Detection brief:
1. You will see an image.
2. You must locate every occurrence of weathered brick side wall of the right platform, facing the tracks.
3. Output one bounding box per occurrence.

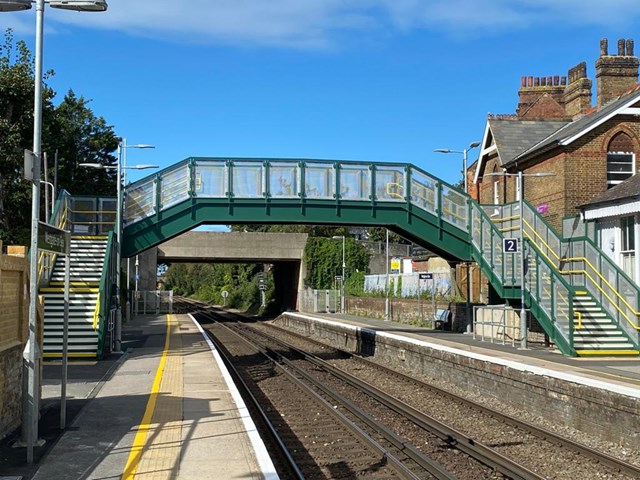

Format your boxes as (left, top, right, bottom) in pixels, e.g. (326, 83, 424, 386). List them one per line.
(277, 314, 640, 449)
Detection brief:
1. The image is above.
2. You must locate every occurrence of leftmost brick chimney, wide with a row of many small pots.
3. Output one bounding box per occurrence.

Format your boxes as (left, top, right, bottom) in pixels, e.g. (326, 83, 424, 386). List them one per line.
(516, 75, 567, 120)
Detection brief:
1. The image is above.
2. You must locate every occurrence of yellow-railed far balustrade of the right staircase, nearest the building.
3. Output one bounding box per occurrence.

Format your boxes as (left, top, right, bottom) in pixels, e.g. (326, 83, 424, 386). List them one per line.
(523, 201, 640, 343)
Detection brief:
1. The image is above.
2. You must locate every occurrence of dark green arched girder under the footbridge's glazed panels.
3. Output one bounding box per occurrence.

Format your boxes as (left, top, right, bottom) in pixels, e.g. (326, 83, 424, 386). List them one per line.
(122, 198, 471, 261)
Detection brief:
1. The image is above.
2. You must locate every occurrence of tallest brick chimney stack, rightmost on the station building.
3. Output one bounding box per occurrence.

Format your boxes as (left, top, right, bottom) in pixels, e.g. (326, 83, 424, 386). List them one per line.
(596, 38, 640, 107)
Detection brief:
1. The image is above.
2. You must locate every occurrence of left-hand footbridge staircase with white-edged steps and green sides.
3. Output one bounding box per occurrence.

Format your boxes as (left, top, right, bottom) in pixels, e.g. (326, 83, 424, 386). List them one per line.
(38, 191, 116, 358)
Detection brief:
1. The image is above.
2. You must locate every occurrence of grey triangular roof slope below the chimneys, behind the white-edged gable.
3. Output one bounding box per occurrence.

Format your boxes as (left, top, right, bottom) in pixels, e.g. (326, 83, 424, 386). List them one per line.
(488, 118, 569, 165)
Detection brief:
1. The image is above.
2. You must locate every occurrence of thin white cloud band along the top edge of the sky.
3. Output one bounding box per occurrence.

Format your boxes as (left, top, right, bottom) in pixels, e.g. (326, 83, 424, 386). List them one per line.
(8, 0, 640, 48)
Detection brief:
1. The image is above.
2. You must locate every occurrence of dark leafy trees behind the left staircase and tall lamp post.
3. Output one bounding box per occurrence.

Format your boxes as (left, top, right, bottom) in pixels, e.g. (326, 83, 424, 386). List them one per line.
(0, 29, 118, 245)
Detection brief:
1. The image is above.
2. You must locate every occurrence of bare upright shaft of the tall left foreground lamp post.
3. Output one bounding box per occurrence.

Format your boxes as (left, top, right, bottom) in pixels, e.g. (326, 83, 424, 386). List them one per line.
(23, 0, 44, 464)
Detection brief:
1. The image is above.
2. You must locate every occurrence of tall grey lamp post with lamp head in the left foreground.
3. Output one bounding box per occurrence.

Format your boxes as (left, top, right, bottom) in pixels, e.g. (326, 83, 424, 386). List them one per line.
(0, 0, 107, 464)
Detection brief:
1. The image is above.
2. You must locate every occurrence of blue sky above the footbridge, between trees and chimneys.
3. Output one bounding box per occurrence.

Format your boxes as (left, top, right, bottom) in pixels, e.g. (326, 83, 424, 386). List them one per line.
(0, 0, 640, 187)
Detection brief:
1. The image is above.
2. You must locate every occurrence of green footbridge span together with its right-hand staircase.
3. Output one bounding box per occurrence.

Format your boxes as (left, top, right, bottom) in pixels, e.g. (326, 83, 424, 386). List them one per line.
(46, 158, 640, 356)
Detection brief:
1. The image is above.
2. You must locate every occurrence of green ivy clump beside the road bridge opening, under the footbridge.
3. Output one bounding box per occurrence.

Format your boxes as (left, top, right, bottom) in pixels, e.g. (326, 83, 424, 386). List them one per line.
(304, 237, 369, 288)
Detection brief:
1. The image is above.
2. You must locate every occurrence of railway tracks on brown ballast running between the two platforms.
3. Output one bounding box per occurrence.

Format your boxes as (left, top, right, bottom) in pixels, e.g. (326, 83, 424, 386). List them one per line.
(175, 298, 640, 479)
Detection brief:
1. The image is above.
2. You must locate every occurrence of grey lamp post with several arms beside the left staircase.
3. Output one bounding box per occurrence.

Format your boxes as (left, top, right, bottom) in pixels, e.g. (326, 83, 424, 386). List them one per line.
(79, 154, 158, 353)
